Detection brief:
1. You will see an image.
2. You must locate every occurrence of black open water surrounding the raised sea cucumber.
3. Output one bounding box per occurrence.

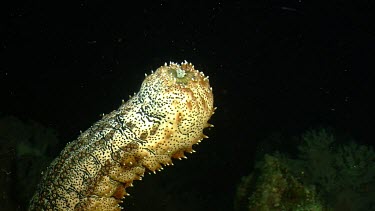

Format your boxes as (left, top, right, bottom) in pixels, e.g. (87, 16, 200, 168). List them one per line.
(0, 0, 375, 211)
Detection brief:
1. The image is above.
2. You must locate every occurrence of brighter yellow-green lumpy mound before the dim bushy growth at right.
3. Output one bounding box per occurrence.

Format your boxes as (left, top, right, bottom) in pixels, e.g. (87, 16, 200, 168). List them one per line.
(237, 154, 322, 211)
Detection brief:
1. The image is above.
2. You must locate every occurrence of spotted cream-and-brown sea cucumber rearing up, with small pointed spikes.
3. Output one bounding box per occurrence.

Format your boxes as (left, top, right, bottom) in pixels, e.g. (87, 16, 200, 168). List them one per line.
(29, 62, 214, 210)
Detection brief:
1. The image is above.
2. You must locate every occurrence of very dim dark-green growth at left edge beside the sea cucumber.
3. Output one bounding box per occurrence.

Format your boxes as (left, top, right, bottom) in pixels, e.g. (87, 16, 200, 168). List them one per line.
(0, 116, 58, 210)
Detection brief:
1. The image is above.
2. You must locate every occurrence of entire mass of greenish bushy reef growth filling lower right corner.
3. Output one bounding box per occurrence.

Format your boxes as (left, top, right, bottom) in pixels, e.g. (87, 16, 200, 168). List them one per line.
(235, 129, 375, 211)
